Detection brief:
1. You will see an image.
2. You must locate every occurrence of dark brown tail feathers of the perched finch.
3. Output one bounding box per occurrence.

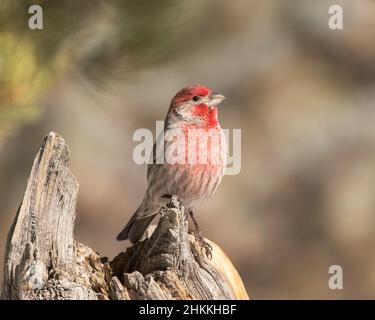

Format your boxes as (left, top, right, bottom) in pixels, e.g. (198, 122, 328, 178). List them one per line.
(117, 201, 159, 243)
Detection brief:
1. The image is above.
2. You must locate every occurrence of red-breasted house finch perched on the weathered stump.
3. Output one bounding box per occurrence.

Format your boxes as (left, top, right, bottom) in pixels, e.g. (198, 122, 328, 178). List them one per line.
(117, 84, 226, 250)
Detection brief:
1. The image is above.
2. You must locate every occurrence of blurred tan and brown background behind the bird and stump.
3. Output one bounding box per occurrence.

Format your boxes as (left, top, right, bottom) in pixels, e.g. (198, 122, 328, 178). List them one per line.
(0, 0, 375, 299)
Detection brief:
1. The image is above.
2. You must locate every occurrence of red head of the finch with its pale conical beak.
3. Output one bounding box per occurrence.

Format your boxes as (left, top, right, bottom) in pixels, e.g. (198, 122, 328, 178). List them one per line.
(167, 84, 225, 128)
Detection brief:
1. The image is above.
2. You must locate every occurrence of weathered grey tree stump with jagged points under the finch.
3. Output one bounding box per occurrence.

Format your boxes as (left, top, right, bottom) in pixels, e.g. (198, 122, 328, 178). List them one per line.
(2, 133, 248, 300)
